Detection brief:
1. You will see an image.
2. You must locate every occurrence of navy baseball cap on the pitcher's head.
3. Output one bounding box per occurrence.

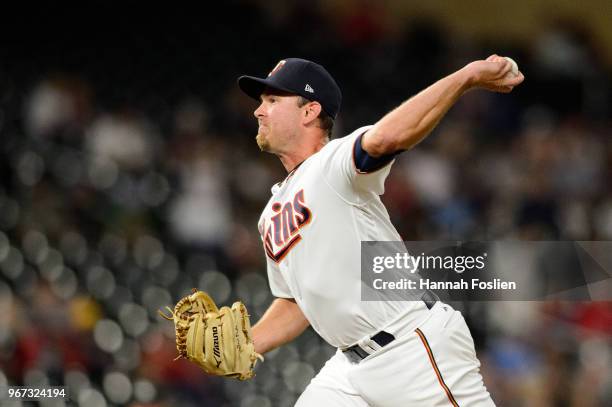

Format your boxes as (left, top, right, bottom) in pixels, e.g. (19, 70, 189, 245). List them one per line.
(238, 58, 342, 119)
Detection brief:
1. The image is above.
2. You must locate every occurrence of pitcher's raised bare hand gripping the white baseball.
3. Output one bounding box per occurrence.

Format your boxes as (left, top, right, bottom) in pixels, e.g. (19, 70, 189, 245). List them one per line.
(464, 54, 525, 93)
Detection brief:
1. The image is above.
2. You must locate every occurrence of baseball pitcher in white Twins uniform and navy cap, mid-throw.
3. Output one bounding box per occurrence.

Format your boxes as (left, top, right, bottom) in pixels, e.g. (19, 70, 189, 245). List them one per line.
(238, 55, 524, 407)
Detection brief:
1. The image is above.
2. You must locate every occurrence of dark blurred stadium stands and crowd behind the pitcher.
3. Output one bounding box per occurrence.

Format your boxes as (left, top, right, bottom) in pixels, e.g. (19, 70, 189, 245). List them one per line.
(0, 0, 612, 407)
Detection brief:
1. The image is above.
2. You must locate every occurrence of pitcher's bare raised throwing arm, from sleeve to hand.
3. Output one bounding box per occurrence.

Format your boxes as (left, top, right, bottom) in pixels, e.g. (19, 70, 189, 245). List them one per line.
(361, 55, 524, 157)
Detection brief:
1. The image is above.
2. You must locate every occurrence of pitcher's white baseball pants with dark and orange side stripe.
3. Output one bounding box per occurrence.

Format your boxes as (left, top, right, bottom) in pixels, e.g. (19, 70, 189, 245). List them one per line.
(296, 301, 495, 407)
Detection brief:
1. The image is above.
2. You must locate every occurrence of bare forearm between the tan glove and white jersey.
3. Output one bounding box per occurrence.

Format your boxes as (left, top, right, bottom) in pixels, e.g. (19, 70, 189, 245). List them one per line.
(253, 298, 310, 354)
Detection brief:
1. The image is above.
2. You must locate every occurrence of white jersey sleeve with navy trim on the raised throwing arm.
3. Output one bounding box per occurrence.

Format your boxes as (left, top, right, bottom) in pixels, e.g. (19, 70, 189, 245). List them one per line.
(323, 126, 399, 201)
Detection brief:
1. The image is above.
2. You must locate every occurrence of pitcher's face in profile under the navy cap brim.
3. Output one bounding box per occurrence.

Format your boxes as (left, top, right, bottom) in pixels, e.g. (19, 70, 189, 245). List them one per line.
(253, 89, 302, 153)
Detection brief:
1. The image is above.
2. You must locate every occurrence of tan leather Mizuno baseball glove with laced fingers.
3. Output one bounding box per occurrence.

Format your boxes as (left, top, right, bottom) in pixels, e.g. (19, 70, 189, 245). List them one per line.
(159, 288, 263, 380)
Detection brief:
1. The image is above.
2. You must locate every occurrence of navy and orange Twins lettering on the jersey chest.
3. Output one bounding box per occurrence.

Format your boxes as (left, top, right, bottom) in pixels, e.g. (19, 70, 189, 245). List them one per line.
(260, 189, 312, 263)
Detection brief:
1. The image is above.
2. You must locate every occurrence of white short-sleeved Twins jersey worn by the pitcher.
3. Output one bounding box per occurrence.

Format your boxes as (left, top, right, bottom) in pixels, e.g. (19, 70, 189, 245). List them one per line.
(259, 126, 418, 347)
